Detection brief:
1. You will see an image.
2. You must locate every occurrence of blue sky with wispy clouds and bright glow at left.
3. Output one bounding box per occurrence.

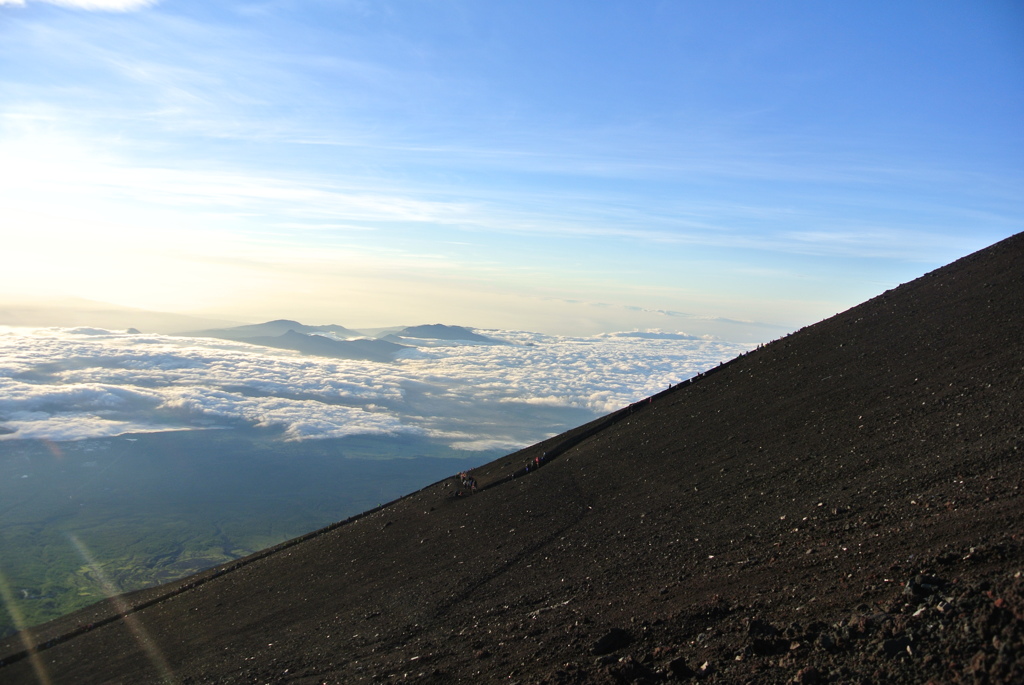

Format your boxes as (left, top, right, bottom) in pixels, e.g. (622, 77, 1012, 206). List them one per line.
(0, 0, 1024, 339)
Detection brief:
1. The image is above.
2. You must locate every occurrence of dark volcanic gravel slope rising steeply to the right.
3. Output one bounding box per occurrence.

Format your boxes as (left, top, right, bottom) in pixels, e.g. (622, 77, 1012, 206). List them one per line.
(0, 234, 1024, 684)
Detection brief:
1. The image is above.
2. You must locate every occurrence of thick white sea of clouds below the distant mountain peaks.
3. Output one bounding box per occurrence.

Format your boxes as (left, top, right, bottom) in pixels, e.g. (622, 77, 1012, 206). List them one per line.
(0, 327, 751, 451)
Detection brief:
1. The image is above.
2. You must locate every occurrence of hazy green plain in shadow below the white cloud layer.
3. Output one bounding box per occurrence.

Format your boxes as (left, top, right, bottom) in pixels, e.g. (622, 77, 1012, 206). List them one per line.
(0, 430, 500, 637)
